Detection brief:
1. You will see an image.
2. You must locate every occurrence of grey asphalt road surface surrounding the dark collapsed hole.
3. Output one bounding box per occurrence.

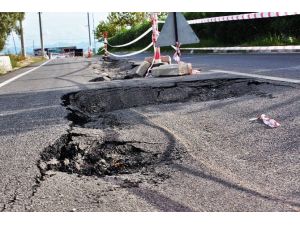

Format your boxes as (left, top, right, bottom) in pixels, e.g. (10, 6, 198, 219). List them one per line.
(0, 54, 300, 211)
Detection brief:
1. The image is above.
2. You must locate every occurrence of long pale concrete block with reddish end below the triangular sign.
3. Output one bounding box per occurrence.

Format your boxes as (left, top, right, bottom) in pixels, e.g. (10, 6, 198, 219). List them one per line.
(151, 62, 193, 77)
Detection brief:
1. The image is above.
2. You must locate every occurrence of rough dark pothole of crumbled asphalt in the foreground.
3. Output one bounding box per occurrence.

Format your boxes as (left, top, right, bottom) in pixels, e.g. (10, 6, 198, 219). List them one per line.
(38, 133, 165, 176)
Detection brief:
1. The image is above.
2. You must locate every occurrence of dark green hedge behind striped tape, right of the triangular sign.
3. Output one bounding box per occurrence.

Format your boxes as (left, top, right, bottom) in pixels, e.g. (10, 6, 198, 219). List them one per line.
(184, 12, 300, 46)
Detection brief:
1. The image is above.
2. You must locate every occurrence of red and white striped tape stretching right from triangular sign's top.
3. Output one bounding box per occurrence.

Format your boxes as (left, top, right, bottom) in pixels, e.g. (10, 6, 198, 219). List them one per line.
(158, 12, 300, 24)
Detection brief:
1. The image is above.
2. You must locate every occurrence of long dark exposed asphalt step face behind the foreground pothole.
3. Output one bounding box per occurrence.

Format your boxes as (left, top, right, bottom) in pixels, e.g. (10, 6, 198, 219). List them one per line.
(68, 78, 274, 116)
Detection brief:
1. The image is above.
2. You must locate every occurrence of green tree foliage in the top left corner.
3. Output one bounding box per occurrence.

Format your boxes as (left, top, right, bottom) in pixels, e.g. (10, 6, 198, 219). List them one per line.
(0, 12, 24, 51)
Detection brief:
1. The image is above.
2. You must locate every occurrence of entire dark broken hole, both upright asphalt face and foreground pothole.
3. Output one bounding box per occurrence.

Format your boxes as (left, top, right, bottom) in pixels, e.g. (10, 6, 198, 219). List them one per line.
(38, 78, 282, 176)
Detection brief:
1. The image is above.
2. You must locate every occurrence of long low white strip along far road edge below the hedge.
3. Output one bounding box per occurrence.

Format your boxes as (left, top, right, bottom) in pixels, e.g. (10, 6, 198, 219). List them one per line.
(179, 45, 300, 51)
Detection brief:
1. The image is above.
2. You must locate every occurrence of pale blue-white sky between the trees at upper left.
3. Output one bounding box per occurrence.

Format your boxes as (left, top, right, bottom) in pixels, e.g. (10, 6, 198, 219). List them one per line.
(4, 12, 108, 52)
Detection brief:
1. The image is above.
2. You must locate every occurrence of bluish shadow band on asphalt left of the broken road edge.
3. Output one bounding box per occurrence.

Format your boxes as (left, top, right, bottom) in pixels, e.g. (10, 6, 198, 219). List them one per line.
(0, 90, 67, 135)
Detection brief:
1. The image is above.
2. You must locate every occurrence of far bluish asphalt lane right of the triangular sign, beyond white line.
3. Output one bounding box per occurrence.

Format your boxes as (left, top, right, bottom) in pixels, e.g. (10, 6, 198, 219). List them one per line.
(133, 53, 300, 79)
